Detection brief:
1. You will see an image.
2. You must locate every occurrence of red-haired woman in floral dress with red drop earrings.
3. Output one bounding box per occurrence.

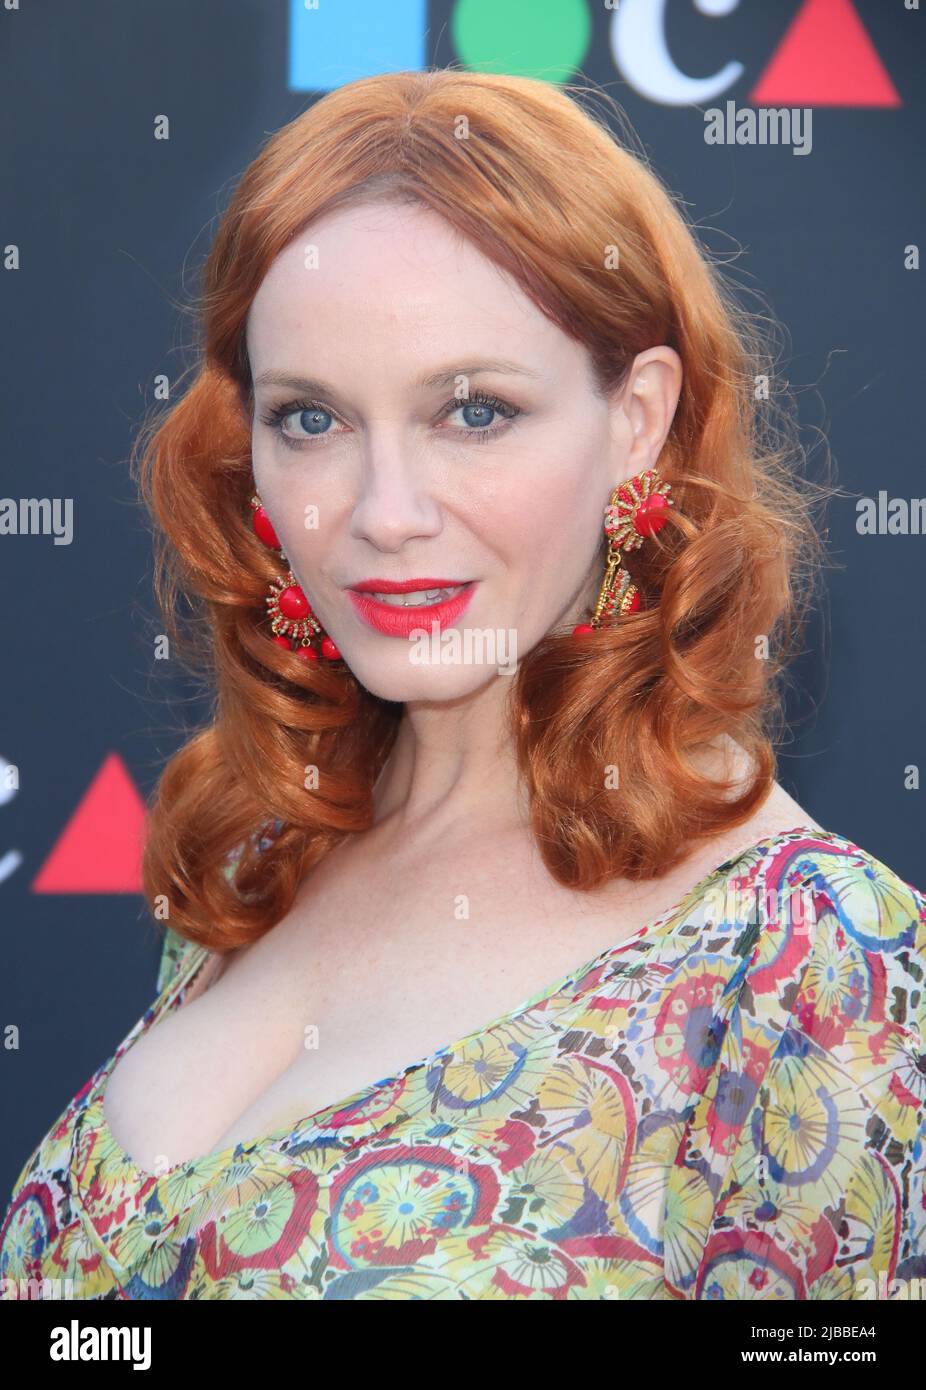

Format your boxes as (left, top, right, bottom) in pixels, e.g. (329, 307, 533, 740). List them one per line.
(0, 71, 926, 1298)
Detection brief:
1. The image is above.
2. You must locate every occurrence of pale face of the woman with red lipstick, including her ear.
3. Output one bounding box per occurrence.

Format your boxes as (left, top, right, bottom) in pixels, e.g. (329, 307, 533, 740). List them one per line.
(247, 202, 681, 702)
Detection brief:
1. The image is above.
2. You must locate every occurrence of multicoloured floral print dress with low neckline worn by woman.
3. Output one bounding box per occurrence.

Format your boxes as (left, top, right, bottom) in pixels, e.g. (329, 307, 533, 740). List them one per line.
(0, 827, 926, 1300)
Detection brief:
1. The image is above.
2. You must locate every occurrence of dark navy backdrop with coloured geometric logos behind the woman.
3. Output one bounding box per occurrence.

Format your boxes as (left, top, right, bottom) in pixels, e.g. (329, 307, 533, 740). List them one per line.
(0, 0, 926, 1205)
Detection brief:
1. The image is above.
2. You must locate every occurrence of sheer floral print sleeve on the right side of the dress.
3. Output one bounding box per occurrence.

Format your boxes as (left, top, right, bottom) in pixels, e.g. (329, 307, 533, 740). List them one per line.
(663, 851, 926, 1300)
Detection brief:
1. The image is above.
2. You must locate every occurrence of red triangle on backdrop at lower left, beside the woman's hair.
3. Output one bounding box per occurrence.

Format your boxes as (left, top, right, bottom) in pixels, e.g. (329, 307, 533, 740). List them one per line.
(32, 753, 147, 892)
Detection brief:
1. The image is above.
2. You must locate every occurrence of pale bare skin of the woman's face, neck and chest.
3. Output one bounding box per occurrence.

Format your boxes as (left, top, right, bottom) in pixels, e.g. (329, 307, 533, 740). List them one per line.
(97, 195, 811, 1169)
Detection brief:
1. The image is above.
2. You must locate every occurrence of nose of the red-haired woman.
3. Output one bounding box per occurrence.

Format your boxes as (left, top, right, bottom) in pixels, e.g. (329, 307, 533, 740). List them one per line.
(349, 438, 442, 552)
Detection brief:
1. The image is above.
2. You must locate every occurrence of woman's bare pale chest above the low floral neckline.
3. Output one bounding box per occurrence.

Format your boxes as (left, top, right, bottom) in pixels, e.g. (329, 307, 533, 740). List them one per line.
(99, 828, 700, 1172)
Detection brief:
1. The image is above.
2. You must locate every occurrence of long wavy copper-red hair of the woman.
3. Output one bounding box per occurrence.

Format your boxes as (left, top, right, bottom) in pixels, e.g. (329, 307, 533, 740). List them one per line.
(133, 68, 820, 951)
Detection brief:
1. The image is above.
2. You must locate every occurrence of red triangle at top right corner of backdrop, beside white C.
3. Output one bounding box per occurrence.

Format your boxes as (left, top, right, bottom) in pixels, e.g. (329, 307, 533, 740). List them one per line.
(749, 0, 895, 106)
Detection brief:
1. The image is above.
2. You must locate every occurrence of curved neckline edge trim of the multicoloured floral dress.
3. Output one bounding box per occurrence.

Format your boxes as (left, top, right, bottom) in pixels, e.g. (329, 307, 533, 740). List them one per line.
(85, 826, 848, 1186)
